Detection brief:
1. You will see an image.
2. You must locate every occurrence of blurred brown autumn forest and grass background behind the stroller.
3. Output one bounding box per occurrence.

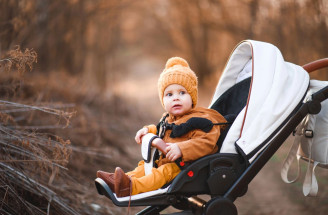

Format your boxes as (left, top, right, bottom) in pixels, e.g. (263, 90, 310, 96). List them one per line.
(0, 0, 328, 214)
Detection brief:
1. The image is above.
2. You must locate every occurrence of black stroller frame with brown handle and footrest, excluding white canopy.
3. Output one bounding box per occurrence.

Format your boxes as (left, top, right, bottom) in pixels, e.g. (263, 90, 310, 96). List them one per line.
(95, 58, 328, 215)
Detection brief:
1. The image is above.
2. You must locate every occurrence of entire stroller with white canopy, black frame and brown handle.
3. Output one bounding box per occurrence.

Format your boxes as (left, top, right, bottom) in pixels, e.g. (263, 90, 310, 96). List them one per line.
(95, 40, 328, 215)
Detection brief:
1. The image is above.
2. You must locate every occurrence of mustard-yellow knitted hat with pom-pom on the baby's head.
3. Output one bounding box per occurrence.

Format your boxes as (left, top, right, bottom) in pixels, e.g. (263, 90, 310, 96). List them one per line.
(158, 57, 198, 107)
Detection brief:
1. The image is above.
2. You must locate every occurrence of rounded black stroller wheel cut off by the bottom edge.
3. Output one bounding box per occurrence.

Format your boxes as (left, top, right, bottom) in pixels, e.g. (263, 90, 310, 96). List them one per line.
(205, 197, 238, 215)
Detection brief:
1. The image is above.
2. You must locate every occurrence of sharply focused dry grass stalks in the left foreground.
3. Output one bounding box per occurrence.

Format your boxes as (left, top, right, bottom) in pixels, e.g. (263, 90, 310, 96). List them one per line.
(0, 47, 79, 214)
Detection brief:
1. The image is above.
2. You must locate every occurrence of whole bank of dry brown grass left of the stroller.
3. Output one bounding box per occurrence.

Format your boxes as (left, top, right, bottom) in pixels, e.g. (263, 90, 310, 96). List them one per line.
(0, 47, 144, 214)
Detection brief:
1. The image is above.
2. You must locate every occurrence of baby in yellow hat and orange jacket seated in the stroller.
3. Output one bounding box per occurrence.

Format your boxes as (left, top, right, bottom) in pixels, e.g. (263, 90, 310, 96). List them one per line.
(97, 57, 226, 197)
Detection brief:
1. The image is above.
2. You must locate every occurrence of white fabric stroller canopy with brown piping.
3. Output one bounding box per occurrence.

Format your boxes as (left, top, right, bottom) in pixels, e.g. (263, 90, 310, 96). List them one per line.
(210, 40, 309, 162)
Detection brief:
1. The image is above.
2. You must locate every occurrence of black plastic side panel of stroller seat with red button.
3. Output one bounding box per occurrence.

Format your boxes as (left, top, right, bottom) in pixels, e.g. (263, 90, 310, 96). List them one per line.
(168, 153, 246, 195)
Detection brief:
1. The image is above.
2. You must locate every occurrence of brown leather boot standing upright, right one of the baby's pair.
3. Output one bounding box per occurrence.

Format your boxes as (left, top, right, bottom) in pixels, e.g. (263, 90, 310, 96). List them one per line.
(114, 167, 132, 197)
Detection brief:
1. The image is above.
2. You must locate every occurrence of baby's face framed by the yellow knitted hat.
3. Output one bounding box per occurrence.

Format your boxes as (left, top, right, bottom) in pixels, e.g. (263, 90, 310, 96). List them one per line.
(163, 84, 192, 116)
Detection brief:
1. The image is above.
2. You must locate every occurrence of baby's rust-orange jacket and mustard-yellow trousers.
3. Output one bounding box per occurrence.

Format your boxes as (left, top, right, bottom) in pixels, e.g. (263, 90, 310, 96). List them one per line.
(126, 107, 227, 195)
